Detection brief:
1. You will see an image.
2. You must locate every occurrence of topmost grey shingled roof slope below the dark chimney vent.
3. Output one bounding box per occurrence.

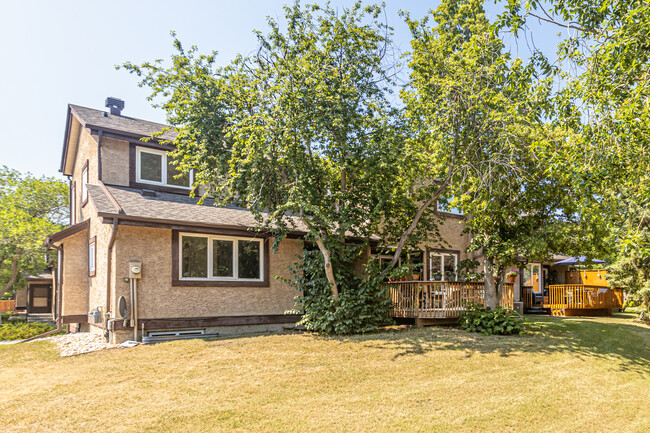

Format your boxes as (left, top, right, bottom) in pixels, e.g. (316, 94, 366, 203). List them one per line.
(68, 104, 176, 140)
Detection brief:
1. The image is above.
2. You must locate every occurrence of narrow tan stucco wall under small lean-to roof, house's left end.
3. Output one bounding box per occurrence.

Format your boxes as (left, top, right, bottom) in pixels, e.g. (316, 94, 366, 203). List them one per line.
(61, 230, 88, 316)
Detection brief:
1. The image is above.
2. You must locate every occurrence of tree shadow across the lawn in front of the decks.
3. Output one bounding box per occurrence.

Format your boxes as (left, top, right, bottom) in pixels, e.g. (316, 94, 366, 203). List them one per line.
(320, 315, 650, 374)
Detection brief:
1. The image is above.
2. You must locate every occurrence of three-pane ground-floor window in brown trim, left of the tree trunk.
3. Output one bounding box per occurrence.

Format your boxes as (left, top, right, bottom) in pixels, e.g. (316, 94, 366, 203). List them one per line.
(179, 233, 264, 281)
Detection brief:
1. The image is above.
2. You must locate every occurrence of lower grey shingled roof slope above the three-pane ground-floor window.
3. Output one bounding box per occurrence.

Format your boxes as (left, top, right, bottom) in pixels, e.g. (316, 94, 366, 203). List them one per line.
(88, 184, 307, 233)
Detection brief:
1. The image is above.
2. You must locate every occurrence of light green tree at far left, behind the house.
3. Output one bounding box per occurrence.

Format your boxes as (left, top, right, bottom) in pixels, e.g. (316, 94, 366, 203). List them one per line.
(0, 166, 68, 316)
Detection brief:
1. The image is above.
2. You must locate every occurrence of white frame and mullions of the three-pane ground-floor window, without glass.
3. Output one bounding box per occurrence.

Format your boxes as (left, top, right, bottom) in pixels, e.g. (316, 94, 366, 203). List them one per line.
(178, 233, 265, 282)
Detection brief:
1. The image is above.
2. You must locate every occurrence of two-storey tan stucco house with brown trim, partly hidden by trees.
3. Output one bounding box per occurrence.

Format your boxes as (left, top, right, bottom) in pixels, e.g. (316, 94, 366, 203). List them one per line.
(46, 98, 469, 342)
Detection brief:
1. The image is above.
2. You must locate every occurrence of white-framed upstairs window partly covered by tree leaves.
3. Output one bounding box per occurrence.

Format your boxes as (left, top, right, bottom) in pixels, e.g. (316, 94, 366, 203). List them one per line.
(136, 148, 192, 189)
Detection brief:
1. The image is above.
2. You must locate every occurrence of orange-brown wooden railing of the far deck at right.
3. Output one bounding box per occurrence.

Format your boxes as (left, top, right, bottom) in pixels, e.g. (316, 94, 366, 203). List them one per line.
(545, 284, 623, 309)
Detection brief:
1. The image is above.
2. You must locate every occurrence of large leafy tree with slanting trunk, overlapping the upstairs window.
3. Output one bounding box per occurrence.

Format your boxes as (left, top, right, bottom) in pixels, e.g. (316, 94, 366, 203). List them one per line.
(123, 2, 403, 330)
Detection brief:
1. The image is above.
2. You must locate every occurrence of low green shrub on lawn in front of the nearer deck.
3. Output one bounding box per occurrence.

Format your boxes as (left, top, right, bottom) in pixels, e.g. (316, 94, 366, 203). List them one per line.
(458, 304, 524, 335)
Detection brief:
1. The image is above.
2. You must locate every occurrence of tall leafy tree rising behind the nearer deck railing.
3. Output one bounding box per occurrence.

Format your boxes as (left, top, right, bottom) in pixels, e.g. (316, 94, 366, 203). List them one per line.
(384, 0, 570, 308)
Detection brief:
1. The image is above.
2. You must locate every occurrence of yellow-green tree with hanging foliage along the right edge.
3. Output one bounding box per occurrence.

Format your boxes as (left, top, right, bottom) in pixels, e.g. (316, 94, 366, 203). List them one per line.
(502, 0, 650, 310)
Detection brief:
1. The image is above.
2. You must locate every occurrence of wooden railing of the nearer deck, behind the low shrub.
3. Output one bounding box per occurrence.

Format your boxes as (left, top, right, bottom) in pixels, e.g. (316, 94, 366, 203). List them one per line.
(388, 281, 514, 319)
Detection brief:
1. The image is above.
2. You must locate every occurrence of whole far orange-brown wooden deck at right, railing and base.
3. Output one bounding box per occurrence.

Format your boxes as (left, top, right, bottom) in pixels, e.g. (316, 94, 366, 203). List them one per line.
(544, 284, 623, 316)
